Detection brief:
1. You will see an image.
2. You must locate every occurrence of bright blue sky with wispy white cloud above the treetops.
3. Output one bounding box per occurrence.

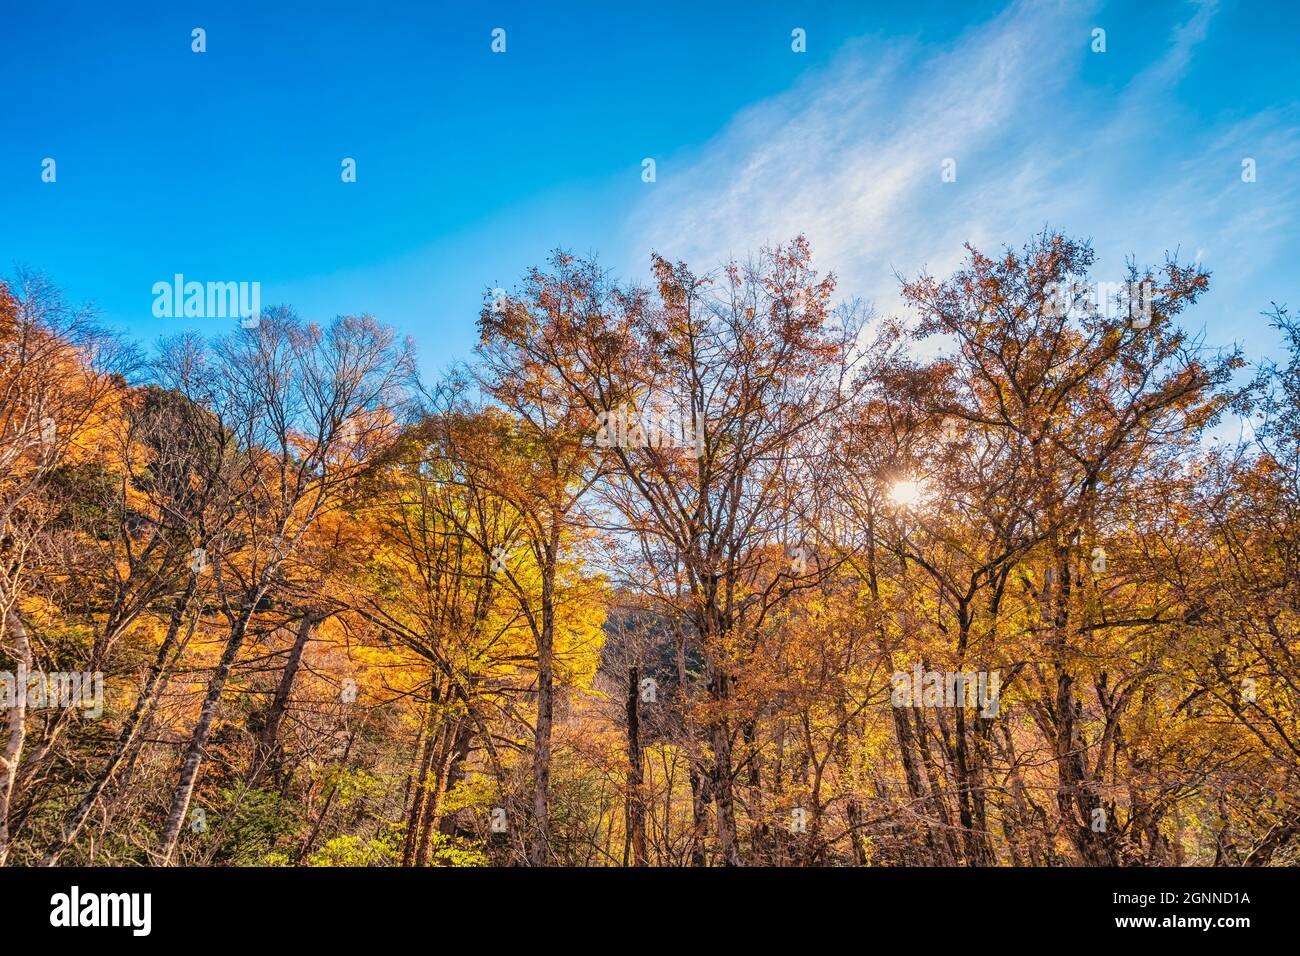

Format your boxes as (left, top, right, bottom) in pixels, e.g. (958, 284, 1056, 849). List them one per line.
(0, 0, 1300, 369)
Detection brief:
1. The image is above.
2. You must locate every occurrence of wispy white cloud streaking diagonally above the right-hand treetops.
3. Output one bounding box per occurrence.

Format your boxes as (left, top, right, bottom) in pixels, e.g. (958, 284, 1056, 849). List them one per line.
(627, 0, 1300, 356)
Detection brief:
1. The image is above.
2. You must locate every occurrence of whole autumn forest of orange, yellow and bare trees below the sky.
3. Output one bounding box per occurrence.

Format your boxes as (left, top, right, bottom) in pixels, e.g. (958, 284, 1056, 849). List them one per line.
(0, 230, 1300, 868)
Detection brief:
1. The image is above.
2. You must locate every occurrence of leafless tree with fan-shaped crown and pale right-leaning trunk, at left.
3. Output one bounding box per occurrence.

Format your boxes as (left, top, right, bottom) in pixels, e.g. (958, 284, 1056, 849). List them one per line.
(156, 308, 412, 865)
